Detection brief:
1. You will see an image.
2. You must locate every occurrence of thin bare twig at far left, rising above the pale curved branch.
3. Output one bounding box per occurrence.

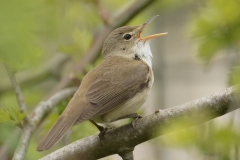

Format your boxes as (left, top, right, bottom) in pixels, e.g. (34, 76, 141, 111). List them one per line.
(5, 65, 27, 113)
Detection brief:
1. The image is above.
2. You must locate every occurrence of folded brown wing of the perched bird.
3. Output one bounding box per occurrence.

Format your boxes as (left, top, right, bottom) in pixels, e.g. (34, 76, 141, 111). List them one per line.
(78, 58, 149, 122)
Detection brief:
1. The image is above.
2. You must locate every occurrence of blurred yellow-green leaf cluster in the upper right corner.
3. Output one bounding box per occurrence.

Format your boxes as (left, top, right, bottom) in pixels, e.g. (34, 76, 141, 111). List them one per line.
(192, 0, 240, 61)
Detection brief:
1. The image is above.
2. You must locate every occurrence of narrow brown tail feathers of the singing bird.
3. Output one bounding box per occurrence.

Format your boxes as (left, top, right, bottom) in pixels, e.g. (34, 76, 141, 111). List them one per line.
(37, 116, 76, 151)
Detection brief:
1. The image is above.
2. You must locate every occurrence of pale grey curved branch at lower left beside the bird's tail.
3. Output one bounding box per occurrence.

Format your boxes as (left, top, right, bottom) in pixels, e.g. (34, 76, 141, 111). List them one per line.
(13, 87, 77, 160)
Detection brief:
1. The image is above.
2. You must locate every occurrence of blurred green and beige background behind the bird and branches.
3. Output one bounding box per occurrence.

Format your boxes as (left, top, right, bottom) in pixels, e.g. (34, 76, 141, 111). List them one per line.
(0, 0, 240, 160)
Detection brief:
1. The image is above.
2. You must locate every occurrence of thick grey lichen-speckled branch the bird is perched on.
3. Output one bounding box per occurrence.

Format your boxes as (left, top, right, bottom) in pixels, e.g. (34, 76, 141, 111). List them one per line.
(40, 86, 240, 160)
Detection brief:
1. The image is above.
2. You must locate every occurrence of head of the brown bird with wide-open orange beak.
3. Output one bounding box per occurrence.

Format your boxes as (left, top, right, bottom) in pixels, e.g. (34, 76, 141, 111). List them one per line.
(102, 15, 167, 58)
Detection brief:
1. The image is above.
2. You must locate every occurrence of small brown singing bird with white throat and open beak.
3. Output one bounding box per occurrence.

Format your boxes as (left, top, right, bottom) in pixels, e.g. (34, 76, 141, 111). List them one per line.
(37, 15, 167, 151)
